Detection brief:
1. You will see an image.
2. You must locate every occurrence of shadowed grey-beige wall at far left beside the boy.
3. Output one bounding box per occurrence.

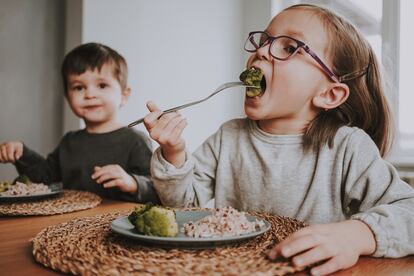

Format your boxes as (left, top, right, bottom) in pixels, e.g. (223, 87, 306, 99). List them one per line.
(0, 0, 64, 181)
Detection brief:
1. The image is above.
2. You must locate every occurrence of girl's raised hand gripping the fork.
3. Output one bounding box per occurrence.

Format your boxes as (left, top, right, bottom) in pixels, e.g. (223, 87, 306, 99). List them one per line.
(144, 102, 187, 167)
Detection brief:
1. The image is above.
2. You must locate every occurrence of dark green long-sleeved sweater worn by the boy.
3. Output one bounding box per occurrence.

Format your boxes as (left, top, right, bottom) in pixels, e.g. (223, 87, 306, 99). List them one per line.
(15, 127, 159, 203)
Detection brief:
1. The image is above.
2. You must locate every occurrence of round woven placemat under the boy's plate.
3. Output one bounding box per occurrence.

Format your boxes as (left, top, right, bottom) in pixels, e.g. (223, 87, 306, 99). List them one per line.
(0, 190, 102, 216)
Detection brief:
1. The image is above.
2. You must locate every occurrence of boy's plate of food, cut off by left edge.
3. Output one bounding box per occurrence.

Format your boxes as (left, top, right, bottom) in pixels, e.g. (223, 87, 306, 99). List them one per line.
(0, 175, 63, 202)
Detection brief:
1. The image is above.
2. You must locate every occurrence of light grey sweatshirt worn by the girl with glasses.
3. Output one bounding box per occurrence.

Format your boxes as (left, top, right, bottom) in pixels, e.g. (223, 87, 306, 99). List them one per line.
(151, 119, 414, 257)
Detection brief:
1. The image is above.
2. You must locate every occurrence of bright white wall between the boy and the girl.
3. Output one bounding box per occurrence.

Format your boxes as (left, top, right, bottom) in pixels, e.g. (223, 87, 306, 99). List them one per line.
(69, 0, 271, 150)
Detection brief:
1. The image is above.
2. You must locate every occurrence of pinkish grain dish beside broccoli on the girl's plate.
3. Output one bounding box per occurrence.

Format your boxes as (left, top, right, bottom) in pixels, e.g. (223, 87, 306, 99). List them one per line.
(181, 206, 265, 238)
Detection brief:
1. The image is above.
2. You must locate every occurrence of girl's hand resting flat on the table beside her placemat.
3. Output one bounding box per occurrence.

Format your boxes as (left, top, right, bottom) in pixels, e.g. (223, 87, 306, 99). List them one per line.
(267, 220, 376, 275)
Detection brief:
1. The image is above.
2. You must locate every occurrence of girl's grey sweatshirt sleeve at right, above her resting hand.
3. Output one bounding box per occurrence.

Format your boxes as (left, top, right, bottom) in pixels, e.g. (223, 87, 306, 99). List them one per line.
(344, 130, 414, 258)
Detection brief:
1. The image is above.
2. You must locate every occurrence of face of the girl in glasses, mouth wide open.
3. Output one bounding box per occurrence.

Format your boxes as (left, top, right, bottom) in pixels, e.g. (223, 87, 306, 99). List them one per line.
(245, 9, 330, 132)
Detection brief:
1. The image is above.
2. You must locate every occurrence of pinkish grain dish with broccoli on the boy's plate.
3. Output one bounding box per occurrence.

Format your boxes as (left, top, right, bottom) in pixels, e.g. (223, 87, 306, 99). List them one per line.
(0, 175, 51, 196)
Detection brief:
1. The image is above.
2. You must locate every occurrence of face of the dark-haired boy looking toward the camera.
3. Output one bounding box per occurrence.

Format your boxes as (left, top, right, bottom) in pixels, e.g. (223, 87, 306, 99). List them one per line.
(67, 64, 130, 128)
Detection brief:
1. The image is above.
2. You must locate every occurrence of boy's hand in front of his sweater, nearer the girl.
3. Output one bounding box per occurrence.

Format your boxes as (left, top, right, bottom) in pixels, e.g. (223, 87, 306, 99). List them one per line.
(92, 165, 138, 194)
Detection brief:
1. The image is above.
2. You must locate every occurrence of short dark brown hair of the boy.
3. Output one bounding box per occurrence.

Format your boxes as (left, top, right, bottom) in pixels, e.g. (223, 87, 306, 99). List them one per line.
(61, 43, 128, 95)
